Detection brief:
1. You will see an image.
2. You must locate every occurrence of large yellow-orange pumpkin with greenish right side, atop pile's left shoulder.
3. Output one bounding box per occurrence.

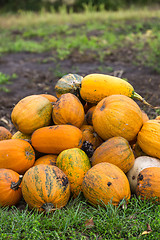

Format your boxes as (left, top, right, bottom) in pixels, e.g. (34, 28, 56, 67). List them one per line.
(11, 95, 52, 135)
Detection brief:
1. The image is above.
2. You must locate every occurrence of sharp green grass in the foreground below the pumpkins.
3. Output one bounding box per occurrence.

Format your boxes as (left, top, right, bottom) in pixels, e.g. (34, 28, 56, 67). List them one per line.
(0, 196, 160, 240)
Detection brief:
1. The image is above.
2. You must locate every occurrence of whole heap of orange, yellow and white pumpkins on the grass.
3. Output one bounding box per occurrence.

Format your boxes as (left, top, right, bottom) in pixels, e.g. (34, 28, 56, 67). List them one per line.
(0, 74, 160, 211)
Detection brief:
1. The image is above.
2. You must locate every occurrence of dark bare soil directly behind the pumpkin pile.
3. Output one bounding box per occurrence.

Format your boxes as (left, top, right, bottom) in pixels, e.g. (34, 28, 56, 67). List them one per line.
(0, 47, 160, 130)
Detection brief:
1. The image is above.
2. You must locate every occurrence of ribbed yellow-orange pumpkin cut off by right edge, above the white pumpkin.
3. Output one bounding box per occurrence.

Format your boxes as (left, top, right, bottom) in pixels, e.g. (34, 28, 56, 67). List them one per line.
(137, 120, 160, 158)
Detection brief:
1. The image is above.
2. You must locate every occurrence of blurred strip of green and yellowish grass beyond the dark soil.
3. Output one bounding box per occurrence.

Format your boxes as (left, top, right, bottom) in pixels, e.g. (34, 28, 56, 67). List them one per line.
(0, 8, 160, 72)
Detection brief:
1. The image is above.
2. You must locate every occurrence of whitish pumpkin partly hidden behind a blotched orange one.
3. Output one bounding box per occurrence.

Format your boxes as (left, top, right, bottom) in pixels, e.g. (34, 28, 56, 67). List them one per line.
(127, 156, 160, 193)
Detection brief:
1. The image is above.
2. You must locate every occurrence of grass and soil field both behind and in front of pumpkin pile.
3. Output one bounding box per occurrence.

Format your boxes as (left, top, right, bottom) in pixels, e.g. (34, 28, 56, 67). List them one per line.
(0, 1, 160, 240)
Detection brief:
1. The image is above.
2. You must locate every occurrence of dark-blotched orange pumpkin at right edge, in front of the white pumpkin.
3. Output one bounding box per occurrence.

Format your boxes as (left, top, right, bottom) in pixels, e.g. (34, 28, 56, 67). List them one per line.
(136, 167, 160, 202)
